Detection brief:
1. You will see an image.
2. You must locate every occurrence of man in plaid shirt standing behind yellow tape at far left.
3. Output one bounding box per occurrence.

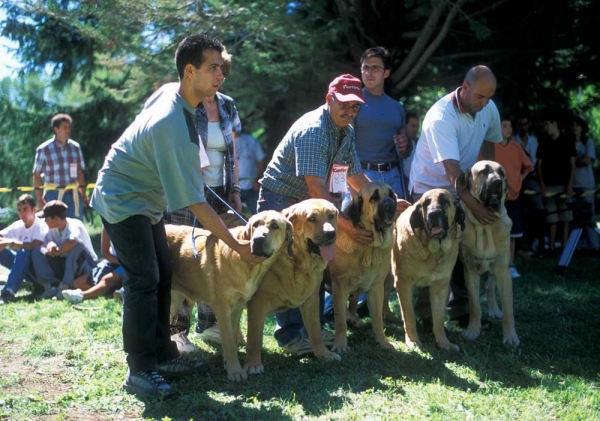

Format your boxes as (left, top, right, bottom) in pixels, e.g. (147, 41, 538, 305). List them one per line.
(33, 114, 88, 219)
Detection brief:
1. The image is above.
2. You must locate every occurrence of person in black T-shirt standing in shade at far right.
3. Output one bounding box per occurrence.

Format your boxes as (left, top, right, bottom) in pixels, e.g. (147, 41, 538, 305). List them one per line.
(537, 112, 576, 257)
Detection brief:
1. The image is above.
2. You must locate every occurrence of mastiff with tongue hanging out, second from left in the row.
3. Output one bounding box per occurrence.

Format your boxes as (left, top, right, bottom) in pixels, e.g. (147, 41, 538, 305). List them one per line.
(244, 199, 340, 374)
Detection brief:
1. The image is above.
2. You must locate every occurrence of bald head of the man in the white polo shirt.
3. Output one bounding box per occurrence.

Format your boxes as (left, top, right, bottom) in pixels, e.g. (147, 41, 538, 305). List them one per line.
(459, 66, 496, 115)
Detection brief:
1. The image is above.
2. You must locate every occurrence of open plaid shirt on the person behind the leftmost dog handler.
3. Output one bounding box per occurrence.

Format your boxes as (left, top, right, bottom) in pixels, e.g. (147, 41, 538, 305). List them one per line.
(196, 92, 242, 200)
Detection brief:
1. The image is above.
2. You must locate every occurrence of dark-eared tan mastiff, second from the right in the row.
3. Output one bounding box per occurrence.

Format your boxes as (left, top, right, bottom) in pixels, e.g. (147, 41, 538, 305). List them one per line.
(392, 189, 465, 351)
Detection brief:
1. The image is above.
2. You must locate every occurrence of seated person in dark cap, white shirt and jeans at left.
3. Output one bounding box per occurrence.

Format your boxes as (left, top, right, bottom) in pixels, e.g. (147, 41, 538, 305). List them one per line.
(32, 200, 97, 299)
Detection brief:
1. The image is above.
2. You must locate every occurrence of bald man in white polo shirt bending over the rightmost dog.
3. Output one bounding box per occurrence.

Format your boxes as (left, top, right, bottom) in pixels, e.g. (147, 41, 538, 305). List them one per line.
(409, 66, 502, 330)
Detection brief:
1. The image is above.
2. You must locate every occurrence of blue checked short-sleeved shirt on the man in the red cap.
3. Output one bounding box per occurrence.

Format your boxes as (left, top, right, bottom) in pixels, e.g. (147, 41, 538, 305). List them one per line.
(260, 105, 361, 201)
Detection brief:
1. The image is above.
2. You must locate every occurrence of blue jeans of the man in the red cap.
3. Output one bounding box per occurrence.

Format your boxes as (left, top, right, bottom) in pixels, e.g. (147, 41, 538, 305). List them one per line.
(258, 187, 325, 346)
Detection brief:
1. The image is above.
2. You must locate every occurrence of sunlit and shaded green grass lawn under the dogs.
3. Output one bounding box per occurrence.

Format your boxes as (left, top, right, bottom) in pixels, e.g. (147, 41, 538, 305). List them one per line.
(0, 236, 600, 421)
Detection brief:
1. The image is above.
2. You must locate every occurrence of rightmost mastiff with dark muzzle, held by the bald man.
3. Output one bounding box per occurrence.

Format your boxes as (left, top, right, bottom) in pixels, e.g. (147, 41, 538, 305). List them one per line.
(456, 161, 519, 345)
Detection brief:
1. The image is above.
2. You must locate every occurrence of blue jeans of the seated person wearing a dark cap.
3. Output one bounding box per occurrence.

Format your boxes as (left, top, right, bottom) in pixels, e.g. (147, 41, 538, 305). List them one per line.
(31, 243, 96, 288)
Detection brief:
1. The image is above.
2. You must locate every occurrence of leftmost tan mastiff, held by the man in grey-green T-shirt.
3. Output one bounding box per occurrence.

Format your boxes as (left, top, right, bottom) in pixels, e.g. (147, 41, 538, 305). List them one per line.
(165, 211, 293, 381)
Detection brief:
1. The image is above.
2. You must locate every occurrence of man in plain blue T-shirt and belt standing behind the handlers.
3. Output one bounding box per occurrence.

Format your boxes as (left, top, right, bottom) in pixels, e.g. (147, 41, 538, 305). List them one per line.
(353, 47, 411, 199)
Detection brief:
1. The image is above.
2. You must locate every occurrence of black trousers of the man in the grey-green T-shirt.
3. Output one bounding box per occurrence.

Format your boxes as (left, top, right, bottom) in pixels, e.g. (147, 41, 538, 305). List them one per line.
(102, 215, 179, 373)
